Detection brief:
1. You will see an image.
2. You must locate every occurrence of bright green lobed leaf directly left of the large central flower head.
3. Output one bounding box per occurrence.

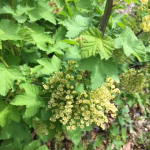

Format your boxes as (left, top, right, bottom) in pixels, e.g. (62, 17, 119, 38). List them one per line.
(11, 84, 44, 117)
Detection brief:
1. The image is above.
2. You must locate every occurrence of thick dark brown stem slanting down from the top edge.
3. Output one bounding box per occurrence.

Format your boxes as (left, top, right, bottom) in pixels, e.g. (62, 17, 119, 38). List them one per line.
(99, 0, 113, 35)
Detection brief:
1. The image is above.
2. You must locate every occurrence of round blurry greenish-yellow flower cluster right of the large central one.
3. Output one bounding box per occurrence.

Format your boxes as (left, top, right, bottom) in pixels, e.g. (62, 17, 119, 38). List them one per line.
(120, 69, 147, 93)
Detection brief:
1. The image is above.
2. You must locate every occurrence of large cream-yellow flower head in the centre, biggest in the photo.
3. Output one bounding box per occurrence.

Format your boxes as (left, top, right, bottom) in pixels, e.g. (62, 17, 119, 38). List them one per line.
(43, 61, 119, 130)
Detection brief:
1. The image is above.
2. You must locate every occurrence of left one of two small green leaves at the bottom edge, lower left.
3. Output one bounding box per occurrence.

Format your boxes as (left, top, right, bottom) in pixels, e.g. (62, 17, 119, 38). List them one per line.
(23, 140, 41, 150)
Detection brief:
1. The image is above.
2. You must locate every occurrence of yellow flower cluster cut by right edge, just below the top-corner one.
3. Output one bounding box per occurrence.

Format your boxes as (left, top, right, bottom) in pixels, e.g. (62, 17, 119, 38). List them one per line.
(140, 15, 150, 32)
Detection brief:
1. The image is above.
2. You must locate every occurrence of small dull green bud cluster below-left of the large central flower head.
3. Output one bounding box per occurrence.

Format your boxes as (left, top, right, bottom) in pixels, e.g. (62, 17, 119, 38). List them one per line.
(32, 119, 49, 136)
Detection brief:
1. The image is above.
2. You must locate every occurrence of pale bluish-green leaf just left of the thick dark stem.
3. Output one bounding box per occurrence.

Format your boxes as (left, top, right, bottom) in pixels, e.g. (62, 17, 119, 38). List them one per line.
(61, 15, 92, 38)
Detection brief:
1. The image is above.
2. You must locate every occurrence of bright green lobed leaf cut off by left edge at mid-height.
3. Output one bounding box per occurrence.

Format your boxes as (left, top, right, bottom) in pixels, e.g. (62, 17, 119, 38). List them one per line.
(0, 63, 25, 96)
